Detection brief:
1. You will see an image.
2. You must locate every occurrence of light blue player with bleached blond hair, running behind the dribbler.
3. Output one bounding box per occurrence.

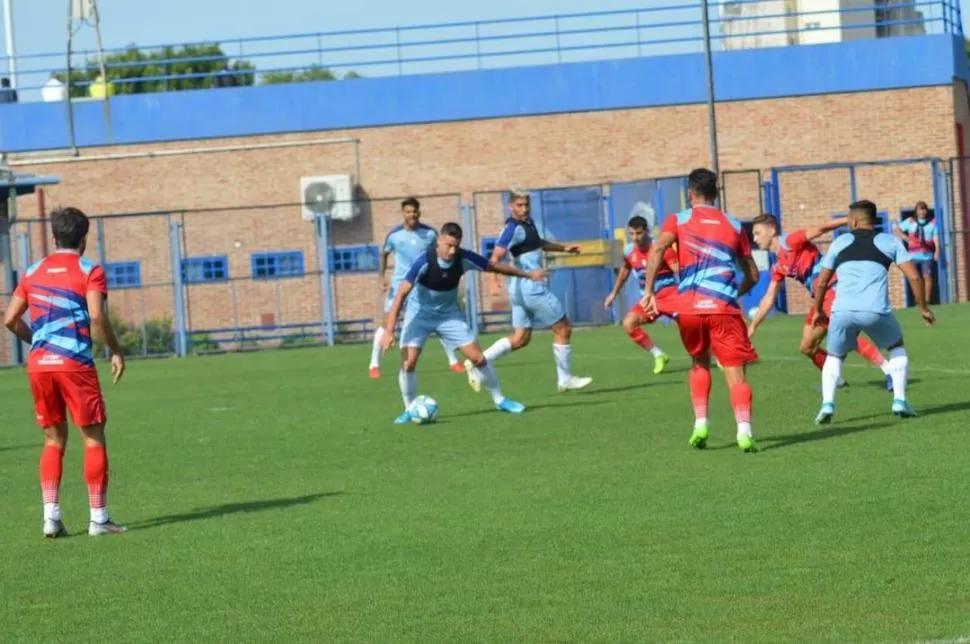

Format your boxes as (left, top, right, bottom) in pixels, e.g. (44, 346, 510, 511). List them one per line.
(465, 188, 593, 391)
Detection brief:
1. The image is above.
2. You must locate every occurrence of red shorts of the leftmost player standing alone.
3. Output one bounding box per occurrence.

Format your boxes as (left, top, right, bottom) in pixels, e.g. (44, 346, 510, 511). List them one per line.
(28, 369, 108, 428)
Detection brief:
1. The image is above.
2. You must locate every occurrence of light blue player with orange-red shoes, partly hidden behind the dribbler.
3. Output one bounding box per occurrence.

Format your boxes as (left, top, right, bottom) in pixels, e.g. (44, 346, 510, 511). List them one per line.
(369, 197, 465, 380)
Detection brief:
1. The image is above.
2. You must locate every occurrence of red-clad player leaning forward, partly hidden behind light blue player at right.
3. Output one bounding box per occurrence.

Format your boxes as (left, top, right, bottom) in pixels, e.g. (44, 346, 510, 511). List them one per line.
(748, 214, 892, 391)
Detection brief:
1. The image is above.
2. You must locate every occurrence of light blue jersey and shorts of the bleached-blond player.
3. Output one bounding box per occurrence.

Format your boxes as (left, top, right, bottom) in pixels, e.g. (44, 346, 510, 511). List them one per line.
(495, 219, 566, 329)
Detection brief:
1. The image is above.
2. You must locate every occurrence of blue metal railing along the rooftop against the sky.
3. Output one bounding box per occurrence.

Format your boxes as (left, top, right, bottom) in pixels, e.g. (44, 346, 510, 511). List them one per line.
(0, 0, 963, 101)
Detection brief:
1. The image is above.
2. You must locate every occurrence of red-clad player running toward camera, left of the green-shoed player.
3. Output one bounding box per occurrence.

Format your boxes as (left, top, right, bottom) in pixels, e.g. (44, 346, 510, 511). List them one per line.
(603, 216, 677, 374)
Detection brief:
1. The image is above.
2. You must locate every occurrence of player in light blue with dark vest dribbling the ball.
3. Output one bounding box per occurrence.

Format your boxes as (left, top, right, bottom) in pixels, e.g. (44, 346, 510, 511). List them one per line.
(381, 223, 547, 424)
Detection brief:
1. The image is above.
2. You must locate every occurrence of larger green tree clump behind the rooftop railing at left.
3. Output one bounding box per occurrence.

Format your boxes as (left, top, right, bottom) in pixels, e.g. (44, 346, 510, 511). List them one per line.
(57, 43, 256, 96)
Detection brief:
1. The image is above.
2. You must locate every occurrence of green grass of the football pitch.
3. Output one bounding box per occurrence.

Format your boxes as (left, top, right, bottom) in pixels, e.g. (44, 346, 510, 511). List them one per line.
(0, 306, 970, 643)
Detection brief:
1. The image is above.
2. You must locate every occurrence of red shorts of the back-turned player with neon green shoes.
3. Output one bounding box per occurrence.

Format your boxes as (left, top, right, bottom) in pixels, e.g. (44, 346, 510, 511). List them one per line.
(677, 314, 758, 367)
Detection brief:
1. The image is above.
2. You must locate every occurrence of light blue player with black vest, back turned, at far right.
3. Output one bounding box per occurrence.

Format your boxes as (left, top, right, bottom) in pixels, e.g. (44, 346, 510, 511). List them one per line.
(815, 200, 936, 425)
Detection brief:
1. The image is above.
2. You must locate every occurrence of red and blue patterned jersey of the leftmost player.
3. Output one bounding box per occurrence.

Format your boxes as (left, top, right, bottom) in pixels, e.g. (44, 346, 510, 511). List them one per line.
(14, 250, 108, 372)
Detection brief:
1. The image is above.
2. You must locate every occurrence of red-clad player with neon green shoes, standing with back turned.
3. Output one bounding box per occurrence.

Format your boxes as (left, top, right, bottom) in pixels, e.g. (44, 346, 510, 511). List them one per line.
(643, 168, 759, 452)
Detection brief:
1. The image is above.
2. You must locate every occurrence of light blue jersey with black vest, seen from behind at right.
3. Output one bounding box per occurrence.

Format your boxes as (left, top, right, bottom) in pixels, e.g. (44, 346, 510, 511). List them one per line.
(822, 230, 912, 314)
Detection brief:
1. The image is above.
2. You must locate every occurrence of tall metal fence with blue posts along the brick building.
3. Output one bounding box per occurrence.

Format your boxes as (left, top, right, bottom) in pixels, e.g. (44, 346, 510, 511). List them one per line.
(0, 158, 970, 364)
